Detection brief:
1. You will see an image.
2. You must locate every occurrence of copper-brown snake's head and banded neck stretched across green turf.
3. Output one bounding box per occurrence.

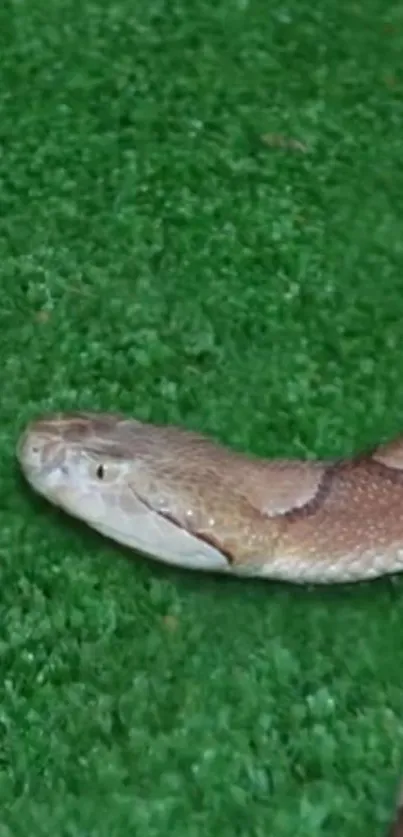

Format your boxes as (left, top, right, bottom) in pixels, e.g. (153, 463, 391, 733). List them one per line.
(17, 412, 403, 584)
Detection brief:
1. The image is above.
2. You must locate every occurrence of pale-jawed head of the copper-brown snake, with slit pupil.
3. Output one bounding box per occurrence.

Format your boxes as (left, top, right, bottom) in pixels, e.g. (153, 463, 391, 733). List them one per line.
(16, 413, 228, 571)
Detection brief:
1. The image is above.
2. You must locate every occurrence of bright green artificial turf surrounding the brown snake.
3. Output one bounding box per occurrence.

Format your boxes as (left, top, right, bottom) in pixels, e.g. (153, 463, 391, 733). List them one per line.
(0, 0, 403, 837)
